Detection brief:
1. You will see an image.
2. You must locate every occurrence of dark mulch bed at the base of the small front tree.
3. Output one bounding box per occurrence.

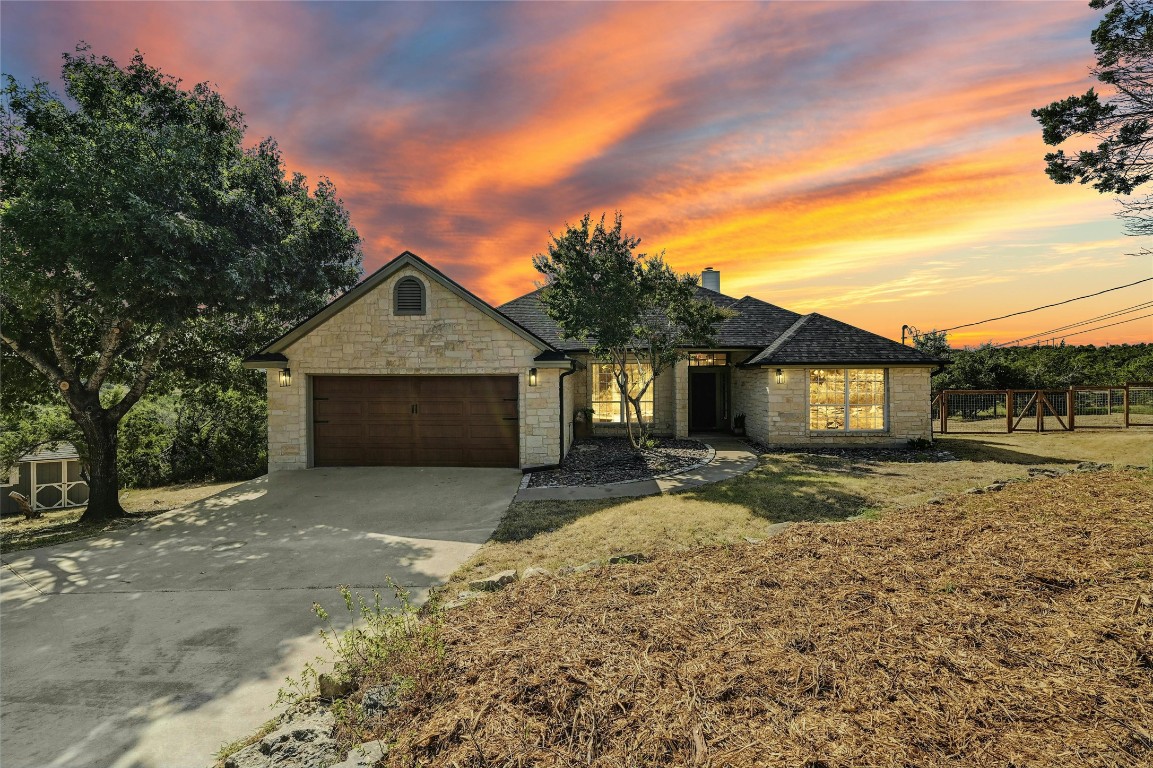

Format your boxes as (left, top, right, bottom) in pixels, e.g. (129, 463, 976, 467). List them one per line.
(528, 437, 709, 488)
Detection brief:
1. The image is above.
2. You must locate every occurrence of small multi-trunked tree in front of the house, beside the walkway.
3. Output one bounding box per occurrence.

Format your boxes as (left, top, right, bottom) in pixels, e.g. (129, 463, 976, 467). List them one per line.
(533, 213, 726, 449)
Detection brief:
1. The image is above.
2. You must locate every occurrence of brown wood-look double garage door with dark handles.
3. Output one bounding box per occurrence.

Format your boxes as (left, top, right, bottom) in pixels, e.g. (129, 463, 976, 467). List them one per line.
(312, 376, 520, 467)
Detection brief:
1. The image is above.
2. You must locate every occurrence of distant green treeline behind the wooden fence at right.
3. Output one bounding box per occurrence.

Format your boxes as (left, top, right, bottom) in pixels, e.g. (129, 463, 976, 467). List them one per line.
(918, 340, 1153, 392)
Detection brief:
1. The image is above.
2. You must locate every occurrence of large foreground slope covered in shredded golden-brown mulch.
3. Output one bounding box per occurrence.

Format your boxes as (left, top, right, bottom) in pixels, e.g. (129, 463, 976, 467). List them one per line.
(379, 472, 1153, 768)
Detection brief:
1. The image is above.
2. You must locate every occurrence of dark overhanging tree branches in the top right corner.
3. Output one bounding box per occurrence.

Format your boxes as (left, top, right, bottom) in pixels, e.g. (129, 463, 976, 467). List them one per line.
(1032, 0, 1153, 234)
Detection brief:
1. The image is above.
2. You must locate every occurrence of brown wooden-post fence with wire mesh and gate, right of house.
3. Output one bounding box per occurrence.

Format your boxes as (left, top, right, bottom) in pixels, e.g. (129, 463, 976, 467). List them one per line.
(933, 383, 1153, 435)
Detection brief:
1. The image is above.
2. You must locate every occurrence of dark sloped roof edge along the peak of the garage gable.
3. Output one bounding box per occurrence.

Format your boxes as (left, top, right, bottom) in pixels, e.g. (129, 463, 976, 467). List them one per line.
(244, 250, 556, 359)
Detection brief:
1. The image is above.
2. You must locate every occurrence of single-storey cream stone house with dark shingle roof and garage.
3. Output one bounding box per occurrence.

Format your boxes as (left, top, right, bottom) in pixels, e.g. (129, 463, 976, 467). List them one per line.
(244, 251, 937, 470)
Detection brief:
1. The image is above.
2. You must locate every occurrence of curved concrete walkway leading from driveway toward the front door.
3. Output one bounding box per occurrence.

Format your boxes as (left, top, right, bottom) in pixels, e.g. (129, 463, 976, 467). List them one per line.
(515, 437, 756, 502)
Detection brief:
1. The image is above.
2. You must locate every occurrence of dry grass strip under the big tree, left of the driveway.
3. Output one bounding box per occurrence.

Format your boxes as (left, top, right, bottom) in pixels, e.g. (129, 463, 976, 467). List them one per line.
(0, 482, 239, 552)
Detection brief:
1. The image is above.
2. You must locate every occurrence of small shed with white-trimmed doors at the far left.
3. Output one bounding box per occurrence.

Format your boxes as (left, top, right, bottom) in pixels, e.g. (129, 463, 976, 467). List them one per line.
(0, 443, 88, 514)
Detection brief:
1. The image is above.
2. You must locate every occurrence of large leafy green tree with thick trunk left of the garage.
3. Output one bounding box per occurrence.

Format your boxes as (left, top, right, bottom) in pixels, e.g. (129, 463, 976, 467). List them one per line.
(0, 45, 361, 519)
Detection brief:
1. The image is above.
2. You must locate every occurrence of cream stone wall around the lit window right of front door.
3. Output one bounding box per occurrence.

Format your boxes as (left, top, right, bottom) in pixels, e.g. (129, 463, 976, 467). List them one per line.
(732, 368, 933, 445)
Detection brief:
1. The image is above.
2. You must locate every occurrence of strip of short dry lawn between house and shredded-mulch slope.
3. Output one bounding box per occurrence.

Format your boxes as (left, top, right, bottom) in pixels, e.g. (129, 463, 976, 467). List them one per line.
(449, 430, 1134, 592)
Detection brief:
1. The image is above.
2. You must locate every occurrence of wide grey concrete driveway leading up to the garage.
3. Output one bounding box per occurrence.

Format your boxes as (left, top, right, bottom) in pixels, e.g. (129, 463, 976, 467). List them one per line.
(0, 468, 521, 768)
